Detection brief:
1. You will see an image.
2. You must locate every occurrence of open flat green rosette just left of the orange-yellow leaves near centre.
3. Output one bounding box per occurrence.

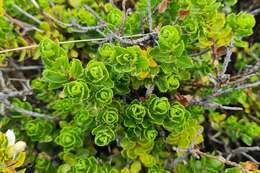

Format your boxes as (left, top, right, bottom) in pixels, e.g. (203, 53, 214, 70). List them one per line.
(114, 46, 140, 73)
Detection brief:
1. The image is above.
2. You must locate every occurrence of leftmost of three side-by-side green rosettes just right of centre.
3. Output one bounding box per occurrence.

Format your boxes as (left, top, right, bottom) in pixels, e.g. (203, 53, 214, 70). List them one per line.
(124, 101, 146, 127)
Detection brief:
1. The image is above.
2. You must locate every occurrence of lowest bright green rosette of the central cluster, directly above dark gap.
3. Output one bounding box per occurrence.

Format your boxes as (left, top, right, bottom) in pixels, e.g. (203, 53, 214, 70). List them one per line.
(92, 125, 115, 146)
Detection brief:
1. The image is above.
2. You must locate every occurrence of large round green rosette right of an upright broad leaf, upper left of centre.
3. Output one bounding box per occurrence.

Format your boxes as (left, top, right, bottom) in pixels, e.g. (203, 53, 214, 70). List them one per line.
(85, 60, 113, 87)
